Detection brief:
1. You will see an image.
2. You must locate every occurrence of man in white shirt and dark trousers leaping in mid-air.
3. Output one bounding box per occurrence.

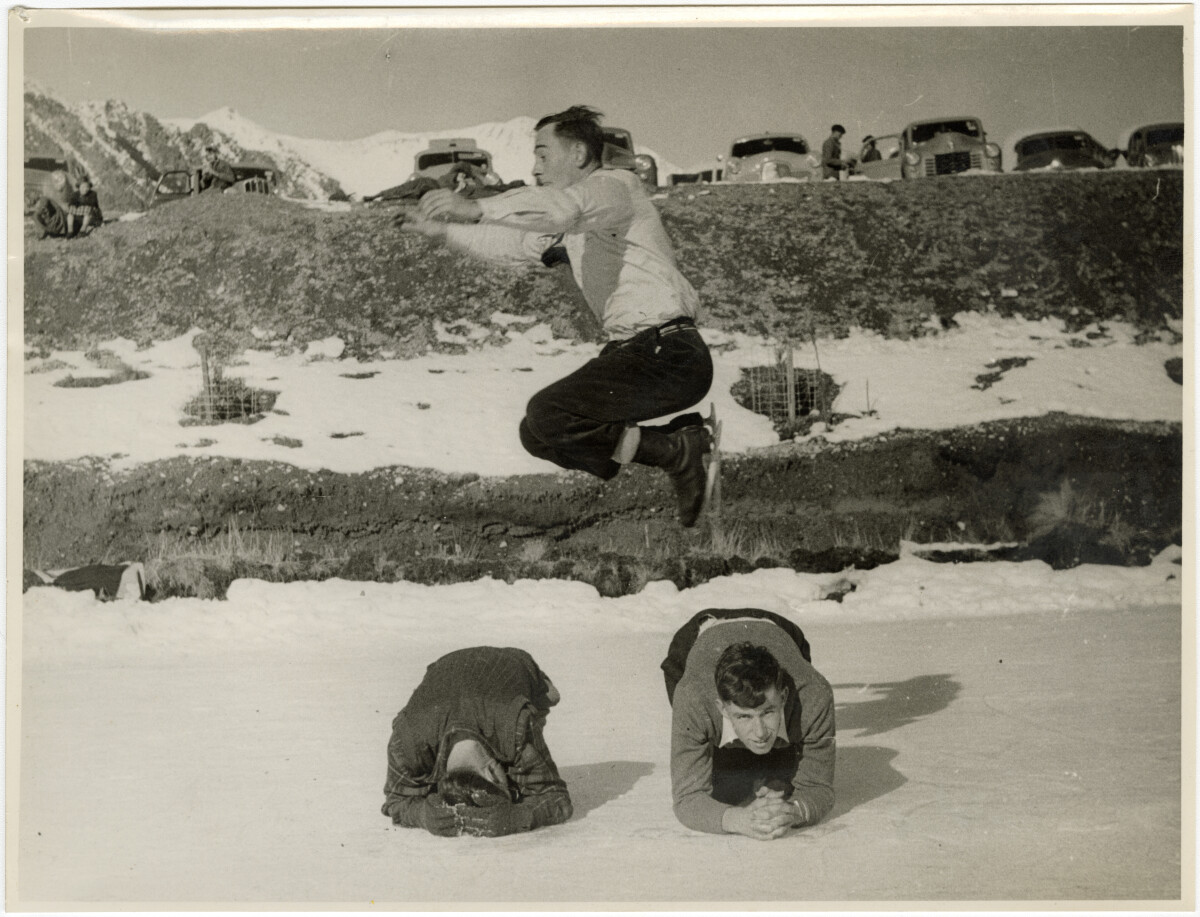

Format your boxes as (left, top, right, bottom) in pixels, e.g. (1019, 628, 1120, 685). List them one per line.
(401, 106, 713, 526)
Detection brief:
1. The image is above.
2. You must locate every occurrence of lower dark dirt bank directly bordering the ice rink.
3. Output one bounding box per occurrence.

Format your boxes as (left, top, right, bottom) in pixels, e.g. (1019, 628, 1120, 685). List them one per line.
(24, 416, 1182, 595)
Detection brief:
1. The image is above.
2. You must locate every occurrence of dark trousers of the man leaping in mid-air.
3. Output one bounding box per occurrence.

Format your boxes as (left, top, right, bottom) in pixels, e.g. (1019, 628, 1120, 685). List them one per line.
(521, 323, 713, 480)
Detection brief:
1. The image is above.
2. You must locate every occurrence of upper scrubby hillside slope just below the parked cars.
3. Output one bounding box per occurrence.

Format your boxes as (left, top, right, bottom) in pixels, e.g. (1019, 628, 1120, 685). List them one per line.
(25, 170, 1183, 356)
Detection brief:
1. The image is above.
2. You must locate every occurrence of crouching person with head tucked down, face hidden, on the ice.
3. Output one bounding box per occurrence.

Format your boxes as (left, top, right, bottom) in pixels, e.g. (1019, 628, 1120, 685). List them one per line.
(383, 647, 571, 838)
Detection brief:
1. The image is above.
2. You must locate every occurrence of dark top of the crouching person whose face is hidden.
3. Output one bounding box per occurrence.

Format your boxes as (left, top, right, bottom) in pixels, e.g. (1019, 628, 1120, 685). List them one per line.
(383, 647, 571, 828)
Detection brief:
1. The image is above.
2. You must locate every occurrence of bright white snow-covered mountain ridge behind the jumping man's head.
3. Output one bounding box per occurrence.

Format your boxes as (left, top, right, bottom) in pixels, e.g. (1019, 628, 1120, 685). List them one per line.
(167, 108, 678, 196)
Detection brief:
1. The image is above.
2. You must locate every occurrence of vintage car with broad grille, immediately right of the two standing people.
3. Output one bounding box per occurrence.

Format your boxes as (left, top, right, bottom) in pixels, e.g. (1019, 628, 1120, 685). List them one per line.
(854, 116, 1001, 179)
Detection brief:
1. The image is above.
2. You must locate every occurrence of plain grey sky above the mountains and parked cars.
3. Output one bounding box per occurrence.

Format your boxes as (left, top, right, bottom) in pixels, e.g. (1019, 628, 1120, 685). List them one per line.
(24, 7, 1184, 166)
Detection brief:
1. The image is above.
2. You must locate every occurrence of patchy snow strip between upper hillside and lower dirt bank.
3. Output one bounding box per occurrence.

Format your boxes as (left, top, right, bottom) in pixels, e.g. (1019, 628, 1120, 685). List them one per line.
(24, 314, 1183, 475)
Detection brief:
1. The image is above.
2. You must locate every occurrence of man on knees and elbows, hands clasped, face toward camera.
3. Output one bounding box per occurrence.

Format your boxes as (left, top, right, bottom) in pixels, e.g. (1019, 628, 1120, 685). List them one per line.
(662, 609, 834, 840)
